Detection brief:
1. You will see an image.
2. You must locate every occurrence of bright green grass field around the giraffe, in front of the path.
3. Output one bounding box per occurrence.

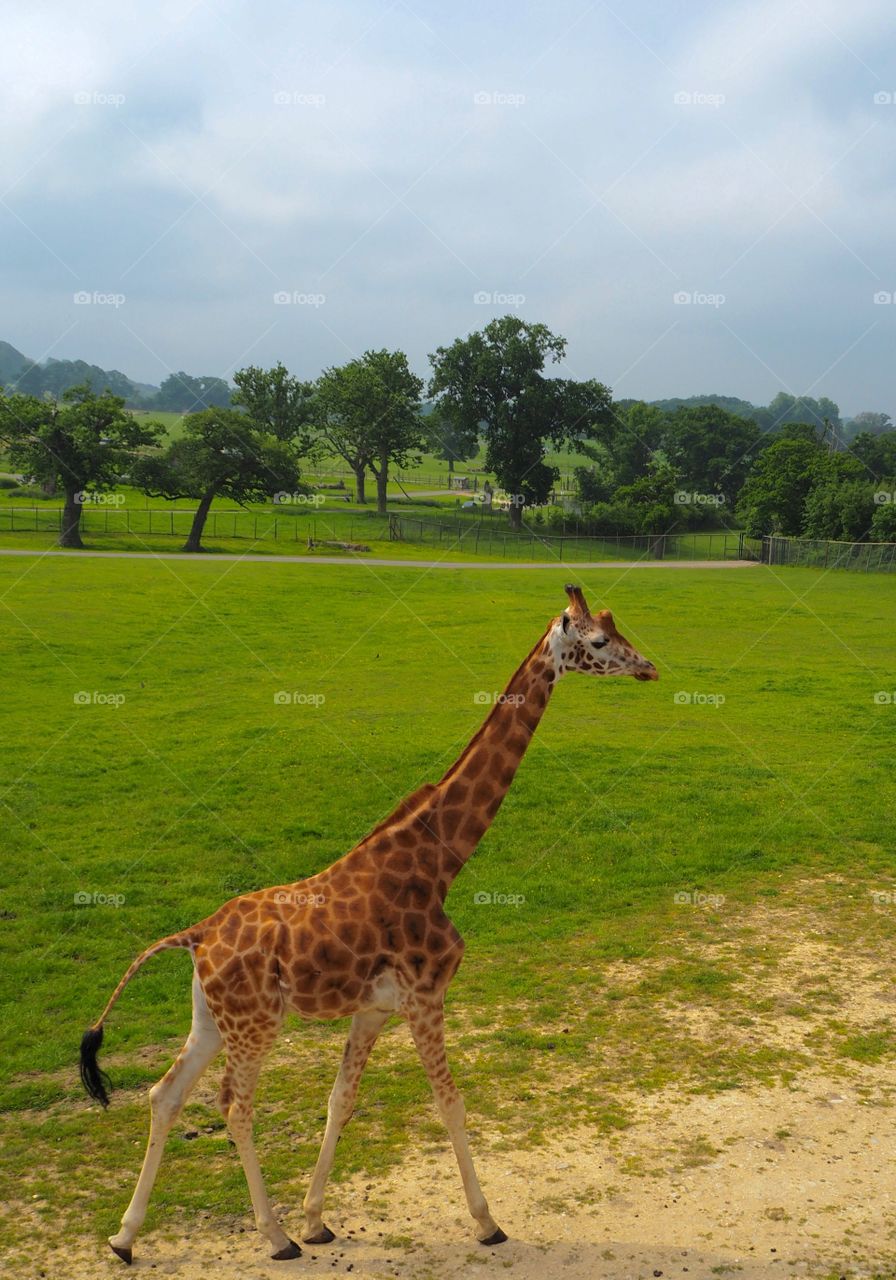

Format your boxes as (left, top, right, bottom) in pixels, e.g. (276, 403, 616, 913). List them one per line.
(0, 554, 896, 1257)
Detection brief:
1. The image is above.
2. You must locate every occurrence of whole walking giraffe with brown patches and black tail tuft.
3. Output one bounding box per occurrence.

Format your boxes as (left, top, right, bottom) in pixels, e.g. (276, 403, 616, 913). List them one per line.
(81, 586, 658, 1265)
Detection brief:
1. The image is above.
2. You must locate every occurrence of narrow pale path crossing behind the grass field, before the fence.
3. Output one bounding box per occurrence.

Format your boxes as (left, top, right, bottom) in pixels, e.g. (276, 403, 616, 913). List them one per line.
(0, 548, 758, 570)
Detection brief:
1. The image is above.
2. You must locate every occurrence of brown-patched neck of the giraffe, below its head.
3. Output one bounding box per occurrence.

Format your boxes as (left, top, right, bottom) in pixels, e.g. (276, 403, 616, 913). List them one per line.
(426, 632, 559, 883)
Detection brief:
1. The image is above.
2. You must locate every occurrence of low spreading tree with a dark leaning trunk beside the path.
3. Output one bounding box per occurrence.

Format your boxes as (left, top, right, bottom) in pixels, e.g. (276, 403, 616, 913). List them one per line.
(133, 408, 300, 552)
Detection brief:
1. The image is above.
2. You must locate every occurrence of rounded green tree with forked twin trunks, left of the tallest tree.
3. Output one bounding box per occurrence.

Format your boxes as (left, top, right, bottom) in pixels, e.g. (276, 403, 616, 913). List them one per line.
(315, 349, 424, 515)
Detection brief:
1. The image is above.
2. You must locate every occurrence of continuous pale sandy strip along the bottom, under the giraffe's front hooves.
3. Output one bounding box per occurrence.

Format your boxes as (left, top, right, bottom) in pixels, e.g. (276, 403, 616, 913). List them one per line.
(35, 1066, 896, 1280)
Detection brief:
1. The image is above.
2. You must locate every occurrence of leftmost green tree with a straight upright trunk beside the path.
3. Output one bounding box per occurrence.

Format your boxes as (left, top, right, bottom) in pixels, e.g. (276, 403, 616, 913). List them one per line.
(0, 384, 164, 548)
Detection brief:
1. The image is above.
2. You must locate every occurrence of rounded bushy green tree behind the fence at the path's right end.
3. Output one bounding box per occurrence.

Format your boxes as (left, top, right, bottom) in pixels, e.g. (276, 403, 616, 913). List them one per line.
(739, 436, 826, 538)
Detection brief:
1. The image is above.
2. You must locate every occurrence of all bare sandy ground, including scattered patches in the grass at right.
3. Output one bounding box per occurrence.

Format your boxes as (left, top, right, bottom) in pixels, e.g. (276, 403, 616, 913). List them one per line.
(14, 882, 896, 1280)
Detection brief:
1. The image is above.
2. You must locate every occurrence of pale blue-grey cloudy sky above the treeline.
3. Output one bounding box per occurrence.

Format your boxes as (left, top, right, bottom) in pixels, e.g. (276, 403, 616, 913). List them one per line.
(0, 0, 896, 417)
